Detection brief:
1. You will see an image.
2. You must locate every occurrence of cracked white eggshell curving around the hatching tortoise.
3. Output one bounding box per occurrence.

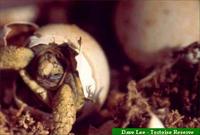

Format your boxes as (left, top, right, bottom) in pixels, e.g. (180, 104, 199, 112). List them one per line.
(29, 24, 110, 105)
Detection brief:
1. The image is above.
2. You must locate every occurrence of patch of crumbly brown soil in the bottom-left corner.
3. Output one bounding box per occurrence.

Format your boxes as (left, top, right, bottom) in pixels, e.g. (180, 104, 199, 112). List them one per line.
(0, 107, 49, 135)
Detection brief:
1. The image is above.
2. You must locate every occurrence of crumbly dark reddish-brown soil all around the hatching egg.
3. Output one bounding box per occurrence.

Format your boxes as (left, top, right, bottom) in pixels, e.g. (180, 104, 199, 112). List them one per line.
(0, 43, 200, 135)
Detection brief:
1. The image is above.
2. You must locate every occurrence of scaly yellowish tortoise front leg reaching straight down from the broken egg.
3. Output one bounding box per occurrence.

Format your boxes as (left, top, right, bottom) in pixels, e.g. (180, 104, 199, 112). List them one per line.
(51, 84, 77, 135)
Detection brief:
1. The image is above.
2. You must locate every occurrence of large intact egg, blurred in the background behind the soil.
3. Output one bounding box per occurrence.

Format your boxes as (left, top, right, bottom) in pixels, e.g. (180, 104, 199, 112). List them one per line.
(115, 0, 200, 65)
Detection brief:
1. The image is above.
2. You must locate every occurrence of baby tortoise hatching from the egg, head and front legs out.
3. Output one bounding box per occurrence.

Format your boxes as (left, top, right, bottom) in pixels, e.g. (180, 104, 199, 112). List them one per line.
(0, 23, 85, 135)
